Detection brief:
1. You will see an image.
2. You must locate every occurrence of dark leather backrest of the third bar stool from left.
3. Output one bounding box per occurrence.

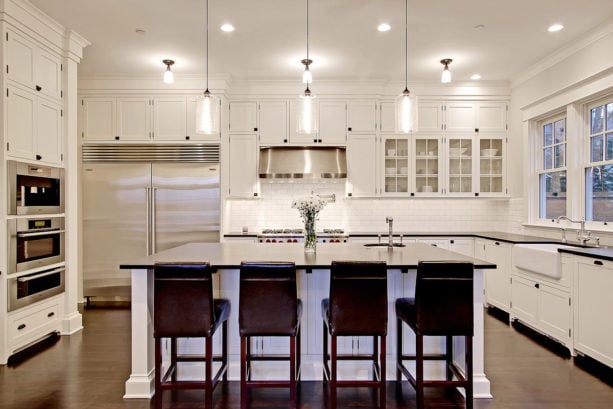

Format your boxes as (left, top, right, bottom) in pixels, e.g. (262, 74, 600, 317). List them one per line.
(329, 261, 388, 335)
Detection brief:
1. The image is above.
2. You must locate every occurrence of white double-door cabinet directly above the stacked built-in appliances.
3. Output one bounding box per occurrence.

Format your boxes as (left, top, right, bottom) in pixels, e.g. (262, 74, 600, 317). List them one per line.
(5, 85, 62, 164)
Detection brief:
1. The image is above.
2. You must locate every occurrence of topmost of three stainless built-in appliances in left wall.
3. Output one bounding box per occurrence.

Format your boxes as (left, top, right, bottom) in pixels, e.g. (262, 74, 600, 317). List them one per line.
(7, 161, 64, 215)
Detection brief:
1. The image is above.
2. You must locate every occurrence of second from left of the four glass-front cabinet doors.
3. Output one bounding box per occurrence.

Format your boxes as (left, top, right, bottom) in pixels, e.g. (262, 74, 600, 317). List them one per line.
(413, 136, 443, 196)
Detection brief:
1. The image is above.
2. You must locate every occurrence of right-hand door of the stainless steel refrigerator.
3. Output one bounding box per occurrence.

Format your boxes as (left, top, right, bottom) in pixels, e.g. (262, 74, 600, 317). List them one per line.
(151, 163, 220, 253)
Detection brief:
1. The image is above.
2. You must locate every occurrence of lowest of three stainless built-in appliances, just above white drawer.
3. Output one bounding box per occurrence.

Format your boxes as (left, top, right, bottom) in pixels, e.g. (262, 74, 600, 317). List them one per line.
(8, 266, 65, 311)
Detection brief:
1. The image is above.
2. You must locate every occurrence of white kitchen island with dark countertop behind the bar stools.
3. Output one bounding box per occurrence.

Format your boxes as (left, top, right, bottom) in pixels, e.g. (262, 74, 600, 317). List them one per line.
(120, 242, 496, 398)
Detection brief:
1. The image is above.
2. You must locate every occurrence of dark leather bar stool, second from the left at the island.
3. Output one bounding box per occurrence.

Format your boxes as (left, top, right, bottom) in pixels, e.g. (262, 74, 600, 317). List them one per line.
(238, 262, 302, 409)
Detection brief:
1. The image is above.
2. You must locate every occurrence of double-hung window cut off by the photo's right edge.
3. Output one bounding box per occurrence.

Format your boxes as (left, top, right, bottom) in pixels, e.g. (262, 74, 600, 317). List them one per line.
(585, 98, 613, 222)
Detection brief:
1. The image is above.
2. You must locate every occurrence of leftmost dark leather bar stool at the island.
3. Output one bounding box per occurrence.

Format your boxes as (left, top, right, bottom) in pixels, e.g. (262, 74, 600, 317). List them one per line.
(153, 263, 230, 409)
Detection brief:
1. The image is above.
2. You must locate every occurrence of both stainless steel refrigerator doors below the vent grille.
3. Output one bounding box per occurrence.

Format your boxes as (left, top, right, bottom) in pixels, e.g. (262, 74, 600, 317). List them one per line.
(82, 162, 220, 300)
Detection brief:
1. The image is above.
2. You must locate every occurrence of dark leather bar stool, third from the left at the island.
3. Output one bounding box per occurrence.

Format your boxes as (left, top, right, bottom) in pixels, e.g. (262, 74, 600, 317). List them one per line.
(321, 261, 387, 409)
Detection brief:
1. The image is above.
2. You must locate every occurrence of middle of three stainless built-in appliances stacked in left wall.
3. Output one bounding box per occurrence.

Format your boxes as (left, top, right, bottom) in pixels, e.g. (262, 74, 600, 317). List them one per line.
(7, 217, 64, 273)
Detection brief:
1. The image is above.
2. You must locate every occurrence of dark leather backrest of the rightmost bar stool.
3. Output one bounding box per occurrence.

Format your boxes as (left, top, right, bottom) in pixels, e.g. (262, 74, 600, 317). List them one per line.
(415, 261, 474, 335)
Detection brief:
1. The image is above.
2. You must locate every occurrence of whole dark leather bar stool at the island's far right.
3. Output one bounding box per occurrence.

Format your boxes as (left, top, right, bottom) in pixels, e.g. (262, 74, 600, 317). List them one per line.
(396, 261, 474, 409)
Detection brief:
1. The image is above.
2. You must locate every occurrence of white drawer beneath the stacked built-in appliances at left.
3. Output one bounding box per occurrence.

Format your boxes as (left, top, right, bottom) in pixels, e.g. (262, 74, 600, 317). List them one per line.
(8, 301, 60, 347)
